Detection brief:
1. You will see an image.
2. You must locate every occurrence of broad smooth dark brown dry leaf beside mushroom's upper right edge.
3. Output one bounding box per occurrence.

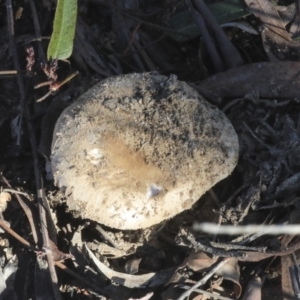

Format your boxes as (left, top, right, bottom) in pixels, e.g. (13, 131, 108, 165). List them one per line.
(199, 61, 300, 100)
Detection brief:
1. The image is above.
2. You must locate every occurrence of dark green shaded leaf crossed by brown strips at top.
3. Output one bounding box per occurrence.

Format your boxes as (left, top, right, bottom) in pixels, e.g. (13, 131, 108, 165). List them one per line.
(170, 0, 251, 42)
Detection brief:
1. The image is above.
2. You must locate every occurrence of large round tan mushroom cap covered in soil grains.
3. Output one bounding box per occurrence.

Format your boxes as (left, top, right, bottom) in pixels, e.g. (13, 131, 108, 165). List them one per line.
(51, 73, 239, 230)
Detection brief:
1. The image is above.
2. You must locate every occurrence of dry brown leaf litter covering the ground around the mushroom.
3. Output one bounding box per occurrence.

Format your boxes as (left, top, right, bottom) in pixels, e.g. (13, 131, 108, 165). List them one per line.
(0, 1, 300, 299)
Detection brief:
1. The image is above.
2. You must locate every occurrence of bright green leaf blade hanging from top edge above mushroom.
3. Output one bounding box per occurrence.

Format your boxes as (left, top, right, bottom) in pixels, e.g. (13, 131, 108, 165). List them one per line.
(47, 0, 77, 60)
